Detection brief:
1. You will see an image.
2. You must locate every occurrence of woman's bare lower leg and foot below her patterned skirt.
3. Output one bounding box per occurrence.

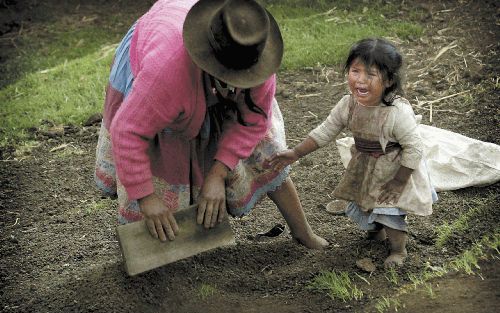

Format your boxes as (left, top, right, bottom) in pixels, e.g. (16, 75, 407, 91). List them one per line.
(267, 177, 328, 249)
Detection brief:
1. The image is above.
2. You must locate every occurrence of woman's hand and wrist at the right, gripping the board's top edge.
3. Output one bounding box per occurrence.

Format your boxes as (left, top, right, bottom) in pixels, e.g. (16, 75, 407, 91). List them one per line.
(196, 161, 228, 228)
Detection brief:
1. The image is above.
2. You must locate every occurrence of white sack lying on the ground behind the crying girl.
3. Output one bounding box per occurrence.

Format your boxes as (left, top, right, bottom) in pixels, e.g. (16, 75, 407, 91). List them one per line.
(336, 124, 500, 191)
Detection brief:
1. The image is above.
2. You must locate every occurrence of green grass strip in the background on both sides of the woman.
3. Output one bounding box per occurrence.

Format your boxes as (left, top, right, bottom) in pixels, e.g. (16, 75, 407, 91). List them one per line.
(0, 0, 422, 146)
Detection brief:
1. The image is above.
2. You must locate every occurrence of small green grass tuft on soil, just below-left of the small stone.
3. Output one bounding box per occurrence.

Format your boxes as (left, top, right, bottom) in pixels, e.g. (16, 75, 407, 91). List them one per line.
(307, 271, 363, 302)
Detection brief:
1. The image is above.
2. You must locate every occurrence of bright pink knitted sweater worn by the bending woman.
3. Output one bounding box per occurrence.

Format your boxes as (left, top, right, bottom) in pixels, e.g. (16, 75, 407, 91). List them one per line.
(107, 0, 276, 199)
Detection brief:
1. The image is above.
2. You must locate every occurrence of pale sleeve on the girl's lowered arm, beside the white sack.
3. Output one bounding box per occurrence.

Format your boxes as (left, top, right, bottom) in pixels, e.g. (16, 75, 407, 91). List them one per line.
(392, 103, 423, 169)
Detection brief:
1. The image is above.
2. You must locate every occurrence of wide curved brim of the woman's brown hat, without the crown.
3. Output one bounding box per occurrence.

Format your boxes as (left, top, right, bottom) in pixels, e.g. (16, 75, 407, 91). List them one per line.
(183, 0, 283, 88)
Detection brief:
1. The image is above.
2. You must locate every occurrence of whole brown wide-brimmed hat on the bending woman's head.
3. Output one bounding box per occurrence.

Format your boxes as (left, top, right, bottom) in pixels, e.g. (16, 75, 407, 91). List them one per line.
(183, 0, 283, 88)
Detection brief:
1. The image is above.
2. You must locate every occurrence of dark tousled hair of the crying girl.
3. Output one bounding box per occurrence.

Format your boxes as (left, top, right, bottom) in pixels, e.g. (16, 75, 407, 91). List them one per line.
(344, 38, 403, 105)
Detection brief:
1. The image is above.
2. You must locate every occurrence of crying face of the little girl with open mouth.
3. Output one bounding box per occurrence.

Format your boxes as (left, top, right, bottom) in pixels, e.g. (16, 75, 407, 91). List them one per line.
(347, 59, 390, 106)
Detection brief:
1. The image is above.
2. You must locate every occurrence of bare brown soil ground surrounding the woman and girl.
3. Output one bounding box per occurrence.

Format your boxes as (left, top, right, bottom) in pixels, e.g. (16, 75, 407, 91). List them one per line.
(0, 1, 500, 313)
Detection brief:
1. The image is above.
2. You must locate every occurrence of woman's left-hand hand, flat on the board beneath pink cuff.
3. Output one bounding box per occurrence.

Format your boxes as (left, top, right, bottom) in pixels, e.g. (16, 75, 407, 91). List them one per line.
(138, 193, 179, 241)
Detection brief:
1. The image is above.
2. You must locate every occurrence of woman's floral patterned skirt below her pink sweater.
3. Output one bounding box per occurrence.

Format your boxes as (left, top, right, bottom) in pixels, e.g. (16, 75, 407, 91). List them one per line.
(94, 101, 290, 224)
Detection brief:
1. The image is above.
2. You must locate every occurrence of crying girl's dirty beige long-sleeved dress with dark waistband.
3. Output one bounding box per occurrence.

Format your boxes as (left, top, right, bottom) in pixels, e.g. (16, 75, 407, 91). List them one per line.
(309, 95, 435, 231)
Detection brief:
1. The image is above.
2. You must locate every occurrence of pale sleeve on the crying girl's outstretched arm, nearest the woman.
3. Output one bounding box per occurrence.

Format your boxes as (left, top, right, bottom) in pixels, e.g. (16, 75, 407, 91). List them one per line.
(309, 95, 350, 147)
